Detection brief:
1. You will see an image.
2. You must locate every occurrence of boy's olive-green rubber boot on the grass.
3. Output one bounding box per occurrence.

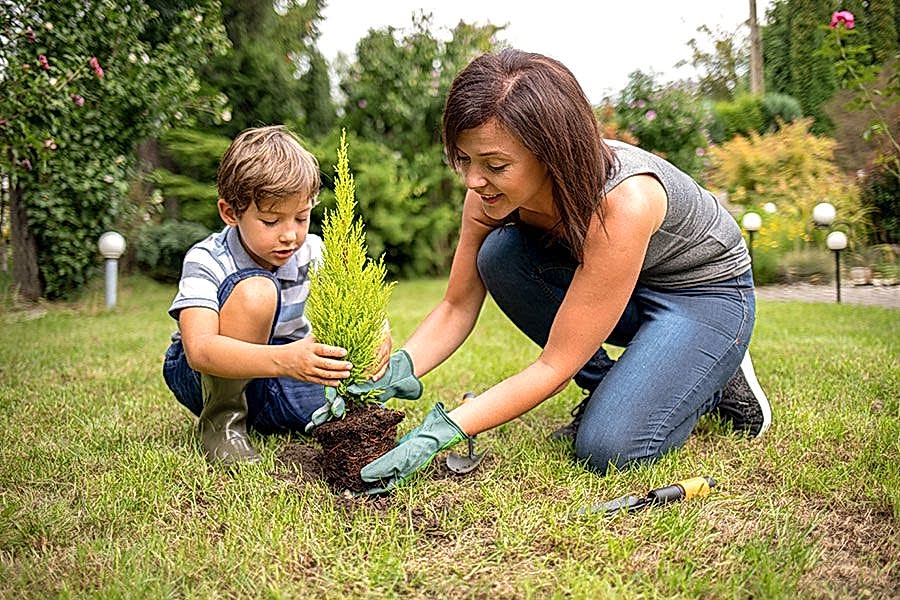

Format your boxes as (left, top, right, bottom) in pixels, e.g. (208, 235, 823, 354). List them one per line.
(199, 373, 262, 467)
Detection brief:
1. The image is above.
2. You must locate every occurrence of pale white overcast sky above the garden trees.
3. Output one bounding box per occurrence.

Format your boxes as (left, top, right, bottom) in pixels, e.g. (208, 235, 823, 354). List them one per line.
(318, 0, 772, 104)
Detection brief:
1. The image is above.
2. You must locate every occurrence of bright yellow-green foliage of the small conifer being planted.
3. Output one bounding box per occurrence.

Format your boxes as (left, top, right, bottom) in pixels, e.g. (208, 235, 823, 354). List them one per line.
(306, 135, 394, 392)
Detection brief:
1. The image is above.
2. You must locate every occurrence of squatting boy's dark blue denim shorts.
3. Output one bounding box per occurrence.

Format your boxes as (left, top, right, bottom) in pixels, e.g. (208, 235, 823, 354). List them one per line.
(163, 269, 325, 434)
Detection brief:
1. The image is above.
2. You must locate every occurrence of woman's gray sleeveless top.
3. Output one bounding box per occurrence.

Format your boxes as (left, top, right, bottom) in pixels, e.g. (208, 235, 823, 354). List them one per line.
(604, 140, 750, 289)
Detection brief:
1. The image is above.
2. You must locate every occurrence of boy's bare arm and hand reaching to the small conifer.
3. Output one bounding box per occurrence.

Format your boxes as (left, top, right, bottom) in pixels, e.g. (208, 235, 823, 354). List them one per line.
(179, 307, 351, 386)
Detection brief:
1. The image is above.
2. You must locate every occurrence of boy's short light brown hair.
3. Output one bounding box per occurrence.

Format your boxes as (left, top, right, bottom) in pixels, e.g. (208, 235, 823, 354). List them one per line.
(216, 125, 320, 216)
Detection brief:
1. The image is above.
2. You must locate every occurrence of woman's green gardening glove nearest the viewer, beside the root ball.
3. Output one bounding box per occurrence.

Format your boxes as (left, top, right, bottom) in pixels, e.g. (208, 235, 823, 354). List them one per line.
(359, 402, 466, 494)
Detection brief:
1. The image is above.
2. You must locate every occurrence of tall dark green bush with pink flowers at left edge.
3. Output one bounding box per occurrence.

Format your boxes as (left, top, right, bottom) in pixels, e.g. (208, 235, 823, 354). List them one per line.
(0, 0, 226, 298)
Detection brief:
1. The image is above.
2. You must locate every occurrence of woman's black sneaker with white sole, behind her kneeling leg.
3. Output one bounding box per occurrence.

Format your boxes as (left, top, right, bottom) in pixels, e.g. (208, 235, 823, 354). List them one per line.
(716, 350, 772, 438)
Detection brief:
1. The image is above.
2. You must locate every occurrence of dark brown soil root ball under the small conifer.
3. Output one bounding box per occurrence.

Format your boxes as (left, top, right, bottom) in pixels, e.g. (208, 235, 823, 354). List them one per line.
(313, 404, 405, 493)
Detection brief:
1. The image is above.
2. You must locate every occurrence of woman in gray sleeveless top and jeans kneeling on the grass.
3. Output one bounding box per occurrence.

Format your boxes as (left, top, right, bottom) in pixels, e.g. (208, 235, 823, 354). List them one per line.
(361, 49, 771, 489)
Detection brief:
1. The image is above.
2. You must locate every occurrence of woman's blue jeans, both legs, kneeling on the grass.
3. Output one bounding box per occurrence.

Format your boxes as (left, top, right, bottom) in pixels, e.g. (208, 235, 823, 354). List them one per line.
(478, 225, 756, 473)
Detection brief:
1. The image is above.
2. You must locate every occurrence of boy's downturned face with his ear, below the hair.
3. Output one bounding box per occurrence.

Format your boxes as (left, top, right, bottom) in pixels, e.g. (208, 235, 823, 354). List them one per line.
(218, 194, 314, 271)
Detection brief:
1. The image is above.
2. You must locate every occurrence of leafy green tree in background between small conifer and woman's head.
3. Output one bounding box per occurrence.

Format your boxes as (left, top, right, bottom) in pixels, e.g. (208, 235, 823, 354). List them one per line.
(330, 14, 502, 275)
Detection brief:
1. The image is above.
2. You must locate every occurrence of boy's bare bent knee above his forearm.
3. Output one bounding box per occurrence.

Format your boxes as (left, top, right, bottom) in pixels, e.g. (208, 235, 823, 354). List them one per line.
(219, 276, 280, 344)
